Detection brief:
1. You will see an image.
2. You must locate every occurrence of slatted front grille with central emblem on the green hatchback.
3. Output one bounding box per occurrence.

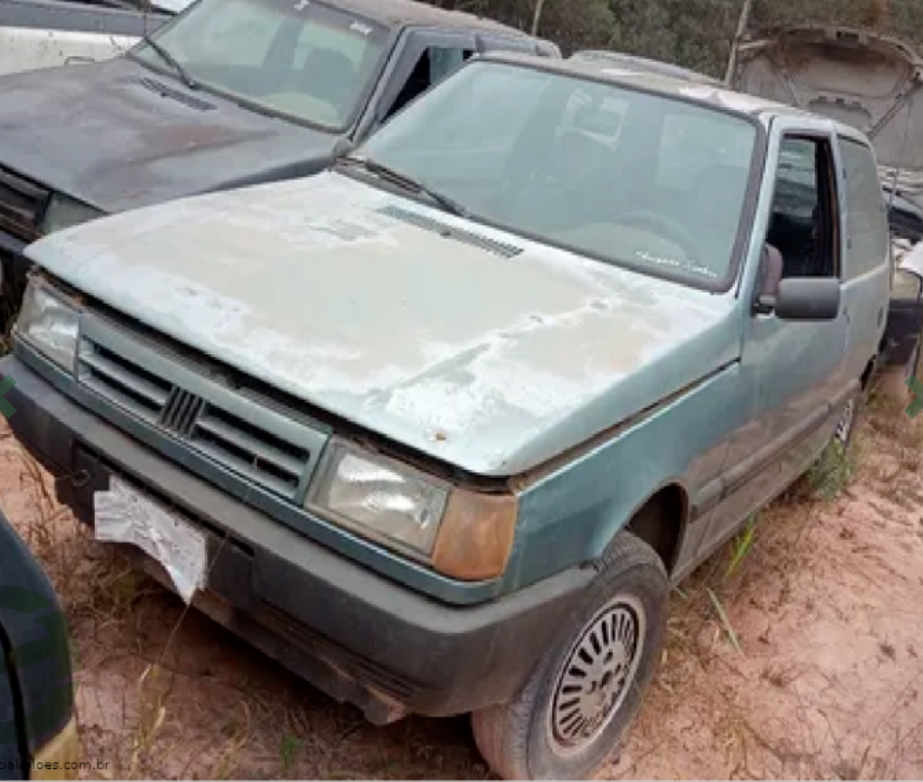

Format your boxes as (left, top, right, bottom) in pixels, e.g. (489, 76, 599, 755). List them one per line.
(77, 334, 319, 499)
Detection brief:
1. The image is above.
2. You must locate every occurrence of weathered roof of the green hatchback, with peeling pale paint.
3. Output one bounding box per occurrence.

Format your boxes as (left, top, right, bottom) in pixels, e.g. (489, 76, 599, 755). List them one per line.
(480, 52, 867, 132)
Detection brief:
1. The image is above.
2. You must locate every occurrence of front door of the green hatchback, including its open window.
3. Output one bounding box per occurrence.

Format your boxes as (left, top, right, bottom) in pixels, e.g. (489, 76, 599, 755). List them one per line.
(702, 119, 848, 548)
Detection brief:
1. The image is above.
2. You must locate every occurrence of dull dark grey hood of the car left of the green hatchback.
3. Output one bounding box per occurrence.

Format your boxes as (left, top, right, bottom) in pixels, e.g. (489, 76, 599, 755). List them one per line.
(0, 57, 336, 213)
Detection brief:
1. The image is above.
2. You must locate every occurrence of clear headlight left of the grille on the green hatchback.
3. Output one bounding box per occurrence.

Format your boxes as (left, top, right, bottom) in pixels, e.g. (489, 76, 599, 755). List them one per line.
(16, 280, 79, 372)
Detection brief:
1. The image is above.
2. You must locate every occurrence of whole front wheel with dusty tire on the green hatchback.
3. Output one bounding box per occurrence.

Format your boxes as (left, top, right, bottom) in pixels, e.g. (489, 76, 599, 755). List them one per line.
(472, 532, 669, 779)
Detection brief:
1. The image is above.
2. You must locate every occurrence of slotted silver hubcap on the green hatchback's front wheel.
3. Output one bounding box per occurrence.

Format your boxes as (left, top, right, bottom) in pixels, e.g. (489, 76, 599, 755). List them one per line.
(548, 595, 646, 755)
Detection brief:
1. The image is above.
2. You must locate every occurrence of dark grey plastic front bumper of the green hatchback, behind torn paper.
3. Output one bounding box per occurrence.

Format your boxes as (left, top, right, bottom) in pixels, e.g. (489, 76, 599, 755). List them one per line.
(0, 356, 592, 723)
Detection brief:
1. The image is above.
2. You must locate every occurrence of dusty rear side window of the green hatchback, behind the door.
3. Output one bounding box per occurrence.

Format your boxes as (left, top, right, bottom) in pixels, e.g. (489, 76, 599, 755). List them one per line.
(840, 138, 889, 278)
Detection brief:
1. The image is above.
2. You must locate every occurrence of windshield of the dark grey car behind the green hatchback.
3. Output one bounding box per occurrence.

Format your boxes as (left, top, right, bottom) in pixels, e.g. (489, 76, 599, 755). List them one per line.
(135, 0, 388, 131)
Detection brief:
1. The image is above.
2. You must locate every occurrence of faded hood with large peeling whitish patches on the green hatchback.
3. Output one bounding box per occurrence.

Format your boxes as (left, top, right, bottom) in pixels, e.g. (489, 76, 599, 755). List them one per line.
(27, 172, 739, 476)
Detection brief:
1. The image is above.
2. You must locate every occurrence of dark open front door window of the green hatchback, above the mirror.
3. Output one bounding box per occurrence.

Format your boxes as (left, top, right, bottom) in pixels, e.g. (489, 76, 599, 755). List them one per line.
(766, 137, 840, 277)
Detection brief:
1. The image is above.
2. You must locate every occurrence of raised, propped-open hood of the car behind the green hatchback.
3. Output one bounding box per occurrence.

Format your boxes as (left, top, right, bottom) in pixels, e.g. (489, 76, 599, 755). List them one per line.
(733, 25, 923, 198)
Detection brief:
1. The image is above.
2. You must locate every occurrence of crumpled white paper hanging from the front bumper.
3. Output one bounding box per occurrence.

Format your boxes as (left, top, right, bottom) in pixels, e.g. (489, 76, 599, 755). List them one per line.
(93, 477, 208, 603)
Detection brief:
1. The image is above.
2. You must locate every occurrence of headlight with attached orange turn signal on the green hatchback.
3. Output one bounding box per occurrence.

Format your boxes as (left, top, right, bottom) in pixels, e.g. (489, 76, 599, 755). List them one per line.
(308, 440, 518, 581)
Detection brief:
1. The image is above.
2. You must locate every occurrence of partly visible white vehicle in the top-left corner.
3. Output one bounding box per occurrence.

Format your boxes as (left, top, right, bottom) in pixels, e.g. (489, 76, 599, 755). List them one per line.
(0, 0, 193, 76)
